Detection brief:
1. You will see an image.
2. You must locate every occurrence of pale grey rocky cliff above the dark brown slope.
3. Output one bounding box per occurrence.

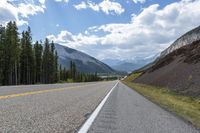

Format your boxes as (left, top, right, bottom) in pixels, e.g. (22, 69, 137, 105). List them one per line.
(160, 26, 200, 58)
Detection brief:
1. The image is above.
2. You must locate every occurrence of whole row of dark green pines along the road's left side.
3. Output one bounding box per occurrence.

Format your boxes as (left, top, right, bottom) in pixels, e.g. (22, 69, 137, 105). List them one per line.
(0, 21, 100, 85)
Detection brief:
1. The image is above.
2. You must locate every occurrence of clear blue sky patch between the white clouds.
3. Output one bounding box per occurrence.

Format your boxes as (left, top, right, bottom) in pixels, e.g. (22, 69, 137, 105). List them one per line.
(25, 0, 178, 40)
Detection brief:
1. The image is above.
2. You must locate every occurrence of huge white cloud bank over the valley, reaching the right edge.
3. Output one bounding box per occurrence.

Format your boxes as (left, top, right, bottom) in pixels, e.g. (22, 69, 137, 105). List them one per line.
(49, 0, 200, 59)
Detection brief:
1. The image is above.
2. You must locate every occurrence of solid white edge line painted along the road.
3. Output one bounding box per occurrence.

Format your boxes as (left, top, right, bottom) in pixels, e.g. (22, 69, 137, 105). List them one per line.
(78, 81, 119, 133)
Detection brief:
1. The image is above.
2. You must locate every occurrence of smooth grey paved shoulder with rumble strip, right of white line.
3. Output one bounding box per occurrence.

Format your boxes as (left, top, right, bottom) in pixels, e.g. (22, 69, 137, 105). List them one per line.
(89, 83, 199, 133)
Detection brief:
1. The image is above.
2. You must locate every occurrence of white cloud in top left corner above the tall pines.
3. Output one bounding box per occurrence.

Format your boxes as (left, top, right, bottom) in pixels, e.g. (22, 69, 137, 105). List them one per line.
(0, 0, 45, 26)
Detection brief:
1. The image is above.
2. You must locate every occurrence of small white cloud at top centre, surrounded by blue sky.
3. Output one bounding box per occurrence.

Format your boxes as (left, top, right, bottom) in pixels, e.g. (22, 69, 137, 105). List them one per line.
(74, 0, 125, 15)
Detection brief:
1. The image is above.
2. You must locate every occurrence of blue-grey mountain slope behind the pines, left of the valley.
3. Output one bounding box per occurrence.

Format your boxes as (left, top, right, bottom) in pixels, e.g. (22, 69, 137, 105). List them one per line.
(55, 44, 116, 73)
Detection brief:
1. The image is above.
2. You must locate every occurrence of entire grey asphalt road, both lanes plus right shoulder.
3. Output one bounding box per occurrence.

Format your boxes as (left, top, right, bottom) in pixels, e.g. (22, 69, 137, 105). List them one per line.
(0, 81, 199, 133)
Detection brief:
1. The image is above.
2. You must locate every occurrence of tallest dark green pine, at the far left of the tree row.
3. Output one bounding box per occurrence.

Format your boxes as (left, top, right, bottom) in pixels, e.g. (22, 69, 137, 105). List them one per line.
(1, 21, 20, 85)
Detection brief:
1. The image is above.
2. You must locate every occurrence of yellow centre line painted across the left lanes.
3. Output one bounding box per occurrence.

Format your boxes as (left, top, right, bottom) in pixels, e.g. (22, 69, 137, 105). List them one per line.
(0, 85, 93, 100)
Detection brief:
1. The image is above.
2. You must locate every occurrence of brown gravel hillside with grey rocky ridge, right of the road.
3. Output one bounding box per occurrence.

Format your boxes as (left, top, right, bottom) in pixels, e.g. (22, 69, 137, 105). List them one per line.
(133, 27, 200, 96)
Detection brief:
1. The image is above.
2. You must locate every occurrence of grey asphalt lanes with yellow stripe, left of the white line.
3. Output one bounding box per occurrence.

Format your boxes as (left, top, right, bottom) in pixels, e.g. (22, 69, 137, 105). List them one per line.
(0, 81, 117, 133)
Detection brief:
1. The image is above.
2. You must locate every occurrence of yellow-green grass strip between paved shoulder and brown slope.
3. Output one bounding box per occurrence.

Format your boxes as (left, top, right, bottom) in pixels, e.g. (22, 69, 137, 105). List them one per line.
(123, 74, 200, 129)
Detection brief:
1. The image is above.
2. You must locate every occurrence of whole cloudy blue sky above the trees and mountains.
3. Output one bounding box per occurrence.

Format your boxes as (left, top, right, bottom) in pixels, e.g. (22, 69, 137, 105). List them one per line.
(0, 0, 200, 61)
